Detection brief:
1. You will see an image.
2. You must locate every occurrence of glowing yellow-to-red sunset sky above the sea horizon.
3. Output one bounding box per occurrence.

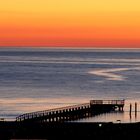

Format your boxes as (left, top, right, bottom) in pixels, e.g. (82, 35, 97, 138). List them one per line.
(0, 0, 140, 48)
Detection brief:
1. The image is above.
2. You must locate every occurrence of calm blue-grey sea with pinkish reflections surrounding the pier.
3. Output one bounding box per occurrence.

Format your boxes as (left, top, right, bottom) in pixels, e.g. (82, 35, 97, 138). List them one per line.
(0, 48, 140, 122)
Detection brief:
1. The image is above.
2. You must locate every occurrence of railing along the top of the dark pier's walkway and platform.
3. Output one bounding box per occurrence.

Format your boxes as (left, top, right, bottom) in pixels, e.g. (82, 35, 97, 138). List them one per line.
(16, 100, 125, 122)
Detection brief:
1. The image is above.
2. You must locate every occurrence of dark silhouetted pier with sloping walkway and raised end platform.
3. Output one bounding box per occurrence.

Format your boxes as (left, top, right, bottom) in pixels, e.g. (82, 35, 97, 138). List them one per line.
(16, 100, 124, 122)
